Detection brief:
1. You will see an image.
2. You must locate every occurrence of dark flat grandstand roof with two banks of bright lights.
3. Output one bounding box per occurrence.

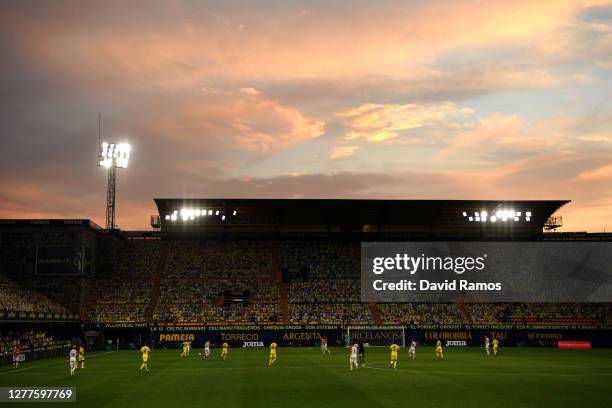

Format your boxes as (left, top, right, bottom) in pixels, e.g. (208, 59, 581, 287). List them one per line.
(155, 198, 569, 237)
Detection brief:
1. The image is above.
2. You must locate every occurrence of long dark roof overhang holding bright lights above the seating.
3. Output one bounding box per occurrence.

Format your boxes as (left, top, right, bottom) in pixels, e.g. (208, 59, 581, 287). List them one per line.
(155, 198, 570, 234)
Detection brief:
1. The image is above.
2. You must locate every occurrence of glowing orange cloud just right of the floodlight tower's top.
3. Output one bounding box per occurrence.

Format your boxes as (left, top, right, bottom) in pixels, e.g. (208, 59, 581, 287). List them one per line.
(143, 88, 325, 155)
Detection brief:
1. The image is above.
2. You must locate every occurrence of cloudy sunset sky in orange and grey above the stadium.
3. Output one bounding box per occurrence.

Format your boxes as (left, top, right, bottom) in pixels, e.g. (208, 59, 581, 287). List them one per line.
(0, 0, 612, 231)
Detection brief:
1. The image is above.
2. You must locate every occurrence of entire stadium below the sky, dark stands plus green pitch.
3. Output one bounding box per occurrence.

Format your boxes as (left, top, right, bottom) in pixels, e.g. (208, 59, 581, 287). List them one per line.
(0, 199, 612, 406)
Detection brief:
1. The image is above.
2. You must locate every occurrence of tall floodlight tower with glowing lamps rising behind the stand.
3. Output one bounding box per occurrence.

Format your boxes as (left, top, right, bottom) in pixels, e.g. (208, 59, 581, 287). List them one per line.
(98, 142, 132, 229)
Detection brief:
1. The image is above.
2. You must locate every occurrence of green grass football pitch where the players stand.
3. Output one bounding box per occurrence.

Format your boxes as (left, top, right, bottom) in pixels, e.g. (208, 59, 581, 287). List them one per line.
(0, 347, 612, 408)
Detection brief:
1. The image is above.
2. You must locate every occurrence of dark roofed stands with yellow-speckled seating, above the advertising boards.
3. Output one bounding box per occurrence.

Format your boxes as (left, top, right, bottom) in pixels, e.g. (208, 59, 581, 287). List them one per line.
(0, 199, 612, 325)
